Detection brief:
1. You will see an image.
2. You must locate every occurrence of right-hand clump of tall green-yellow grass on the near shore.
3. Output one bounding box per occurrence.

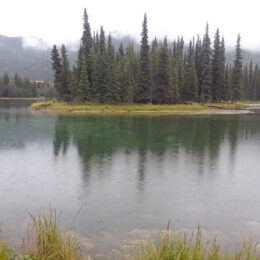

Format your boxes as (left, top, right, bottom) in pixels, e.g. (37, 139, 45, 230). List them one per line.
(133, 229, 260, 260)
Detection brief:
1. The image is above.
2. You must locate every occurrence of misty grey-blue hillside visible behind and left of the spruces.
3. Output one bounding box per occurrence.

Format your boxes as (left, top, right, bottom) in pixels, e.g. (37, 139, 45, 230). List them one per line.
(0, 35, 260, 80)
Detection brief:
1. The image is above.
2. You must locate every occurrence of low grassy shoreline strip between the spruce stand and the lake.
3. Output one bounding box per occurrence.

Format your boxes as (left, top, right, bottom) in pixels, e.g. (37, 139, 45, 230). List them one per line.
(31, 102, 255, 115)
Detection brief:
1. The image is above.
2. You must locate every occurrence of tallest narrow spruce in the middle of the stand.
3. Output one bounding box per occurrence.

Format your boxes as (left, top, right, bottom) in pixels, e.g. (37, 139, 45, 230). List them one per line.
(136, 14, 151, 103)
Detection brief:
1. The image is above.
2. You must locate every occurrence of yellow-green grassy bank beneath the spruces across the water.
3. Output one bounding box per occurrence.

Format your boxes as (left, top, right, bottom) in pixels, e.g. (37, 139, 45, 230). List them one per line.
(31, 101, 248, 113)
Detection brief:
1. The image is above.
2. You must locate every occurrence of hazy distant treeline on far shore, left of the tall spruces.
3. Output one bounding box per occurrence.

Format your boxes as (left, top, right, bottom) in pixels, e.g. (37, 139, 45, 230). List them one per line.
(0, 73, 54, 97)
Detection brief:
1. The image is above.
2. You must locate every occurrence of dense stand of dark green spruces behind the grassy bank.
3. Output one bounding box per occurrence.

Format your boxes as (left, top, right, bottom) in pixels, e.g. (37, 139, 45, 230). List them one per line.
(51, 9, 260, 104)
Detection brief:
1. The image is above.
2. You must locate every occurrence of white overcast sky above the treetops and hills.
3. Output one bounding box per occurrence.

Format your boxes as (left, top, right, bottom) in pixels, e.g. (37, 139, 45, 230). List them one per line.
(0, 0, 260, 50)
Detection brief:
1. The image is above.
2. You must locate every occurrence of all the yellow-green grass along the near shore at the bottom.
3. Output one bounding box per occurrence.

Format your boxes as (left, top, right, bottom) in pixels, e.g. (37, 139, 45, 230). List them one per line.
(0, 213, 260, 260)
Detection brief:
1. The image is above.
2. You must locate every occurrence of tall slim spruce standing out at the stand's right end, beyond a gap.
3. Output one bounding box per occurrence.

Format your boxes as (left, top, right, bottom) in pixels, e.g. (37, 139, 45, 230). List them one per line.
(232, 34, 242, 100)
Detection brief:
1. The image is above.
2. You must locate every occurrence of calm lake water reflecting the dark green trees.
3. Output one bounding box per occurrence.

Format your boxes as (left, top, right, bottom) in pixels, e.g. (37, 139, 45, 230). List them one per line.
(0, 100, 260, 253)
